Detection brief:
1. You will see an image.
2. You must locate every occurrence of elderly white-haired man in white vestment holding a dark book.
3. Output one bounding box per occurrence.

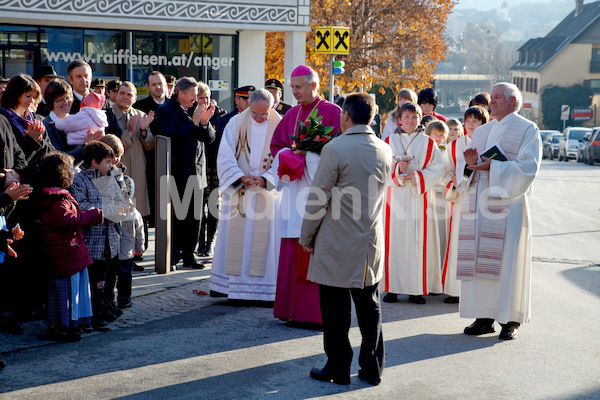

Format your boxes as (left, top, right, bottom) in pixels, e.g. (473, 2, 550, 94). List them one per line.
(456, 82, 541, 340)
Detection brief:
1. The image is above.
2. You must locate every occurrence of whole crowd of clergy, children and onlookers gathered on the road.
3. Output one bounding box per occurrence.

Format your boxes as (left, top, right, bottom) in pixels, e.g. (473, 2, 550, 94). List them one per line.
(0, 60, 541, 385)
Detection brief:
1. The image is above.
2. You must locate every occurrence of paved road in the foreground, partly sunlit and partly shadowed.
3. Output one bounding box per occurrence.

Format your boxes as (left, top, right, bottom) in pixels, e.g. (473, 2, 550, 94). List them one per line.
(0, 161, 600, 400)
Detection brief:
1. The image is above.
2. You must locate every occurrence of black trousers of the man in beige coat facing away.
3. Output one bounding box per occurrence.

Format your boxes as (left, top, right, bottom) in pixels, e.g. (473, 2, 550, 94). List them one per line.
(319, 283, 385, 377)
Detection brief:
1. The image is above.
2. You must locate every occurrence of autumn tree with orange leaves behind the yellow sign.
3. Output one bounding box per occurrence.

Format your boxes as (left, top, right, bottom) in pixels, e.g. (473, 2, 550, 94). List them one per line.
(266, 0, 456, 98)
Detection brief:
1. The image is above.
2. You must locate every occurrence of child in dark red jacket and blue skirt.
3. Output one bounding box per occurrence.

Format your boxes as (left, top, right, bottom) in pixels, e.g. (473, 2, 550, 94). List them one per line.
(36, 153, 103, 342)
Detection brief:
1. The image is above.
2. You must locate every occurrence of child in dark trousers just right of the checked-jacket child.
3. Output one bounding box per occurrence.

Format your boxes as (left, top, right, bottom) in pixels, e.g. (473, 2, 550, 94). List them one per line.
(100, 135, 144, 314)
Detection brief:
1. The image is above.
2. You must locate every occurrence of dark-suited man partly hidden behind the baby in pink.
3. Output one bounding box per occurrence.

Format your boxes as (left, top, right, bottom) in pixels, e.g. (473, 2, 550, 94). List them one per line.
(67, 60, 122, 137)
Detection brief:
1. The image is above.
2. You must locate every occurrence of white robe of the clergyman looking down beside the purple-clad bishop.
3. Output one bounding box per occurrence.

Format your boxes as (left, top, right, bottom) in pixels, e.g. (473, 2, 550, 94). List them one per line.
(210, 115, 281, 301)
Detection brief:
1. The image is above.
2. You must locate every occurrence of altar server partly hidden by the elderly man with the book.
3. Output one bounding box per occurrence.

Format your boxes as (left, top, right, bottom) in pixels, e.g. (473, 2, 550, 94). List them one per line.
(442, 106, 489, 303)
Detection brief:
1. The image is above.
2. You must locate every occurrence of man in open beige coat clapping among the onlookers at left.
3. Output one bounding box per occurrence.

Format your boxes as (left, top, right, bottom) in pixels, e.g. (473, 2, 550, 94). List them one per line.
(112, 82, 154, 220)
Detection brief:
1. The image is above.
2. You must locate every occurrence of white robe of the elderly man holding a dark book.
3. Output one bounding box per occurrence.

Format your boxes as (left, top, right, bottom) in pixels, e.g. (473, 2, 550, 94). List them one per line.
(457, 113, 542, 324)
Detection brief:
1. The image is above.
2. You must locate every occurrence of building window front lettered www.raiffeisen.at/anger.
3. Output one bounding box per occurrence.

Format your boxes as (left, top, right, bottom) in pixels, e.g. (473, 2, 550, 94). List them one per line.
(0, 25, 237, 110)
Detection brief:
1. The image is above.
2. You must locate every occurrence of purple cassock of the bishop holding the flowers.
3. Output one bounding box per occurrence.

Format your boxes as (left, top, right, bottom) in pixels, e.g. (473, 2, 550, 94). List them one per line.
(271, 92, 341, 324)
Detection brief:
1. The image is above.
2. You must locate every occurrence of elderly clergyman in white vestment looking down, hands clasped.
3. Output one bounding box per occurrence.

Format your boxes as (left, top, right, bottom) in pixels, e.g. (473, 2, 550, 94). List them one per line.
(209, 89, 281, 301)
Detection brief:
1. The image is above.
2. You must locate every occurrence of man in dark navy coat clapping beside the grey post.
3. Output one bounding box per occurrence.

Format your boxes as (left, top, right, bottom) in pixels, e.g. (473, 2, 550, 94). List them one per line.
(151, 77, 215, 269)
